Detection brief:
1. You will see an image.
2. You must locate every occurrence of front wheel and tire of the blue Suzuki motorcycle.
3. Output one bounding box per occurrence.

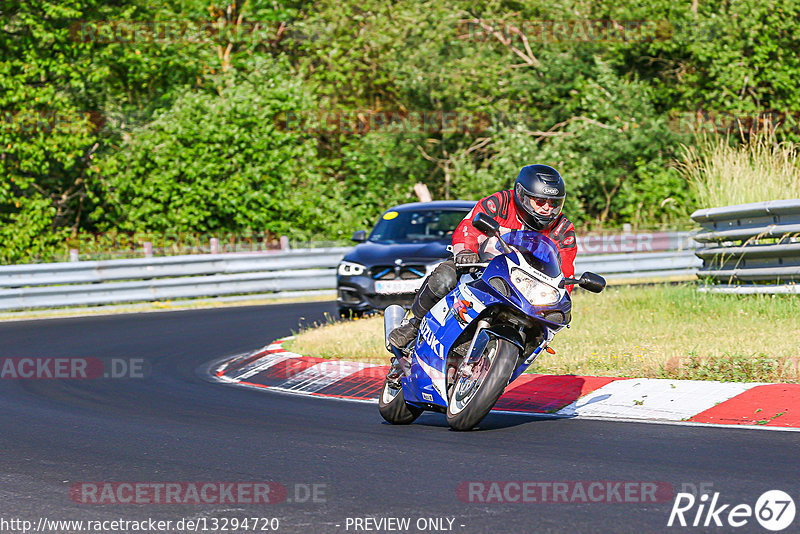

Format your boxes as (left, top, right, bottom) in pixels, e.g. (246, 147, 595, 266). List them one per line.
(447, 339, 519, 430)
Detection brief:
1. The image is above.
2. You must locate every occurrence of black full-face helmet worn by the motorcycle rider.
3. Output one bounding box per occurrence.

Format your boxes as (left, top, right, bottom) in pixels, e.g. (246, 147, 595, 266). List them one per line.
(514, 165, 567, 231)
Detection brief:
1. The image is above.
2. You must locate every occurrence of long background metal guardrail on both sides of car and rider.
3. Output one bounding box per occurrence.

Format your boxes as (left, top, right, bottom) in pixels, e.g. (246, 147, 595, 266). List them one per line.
(0, 232, 700, 310)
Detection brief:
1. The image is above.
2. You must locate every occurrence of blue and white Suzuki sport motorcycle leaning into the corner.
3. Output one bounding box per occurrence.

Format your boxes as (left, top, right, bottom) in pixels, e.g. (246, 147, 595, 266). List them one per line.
(378, 213, 606, 430)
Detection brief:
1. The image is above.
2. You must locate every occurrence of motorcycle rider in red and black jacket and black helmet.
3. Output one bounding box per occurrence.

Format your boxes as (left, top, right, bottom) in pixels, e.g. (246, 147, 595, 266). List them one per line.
(387, 165, 578, 362)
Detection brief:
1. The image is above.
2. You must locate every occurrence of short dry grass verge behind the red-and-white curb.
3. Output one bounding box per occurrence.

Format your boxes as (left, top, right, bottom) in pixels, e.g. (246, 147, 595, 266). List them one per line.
(287, 284, 800, 382)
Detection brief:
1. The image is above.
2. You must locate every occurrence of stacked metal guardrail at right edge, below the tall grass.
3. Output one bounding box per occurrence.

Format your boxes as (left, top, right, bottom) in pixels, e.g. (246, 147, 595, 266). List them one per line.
(692, 199, 800, 293)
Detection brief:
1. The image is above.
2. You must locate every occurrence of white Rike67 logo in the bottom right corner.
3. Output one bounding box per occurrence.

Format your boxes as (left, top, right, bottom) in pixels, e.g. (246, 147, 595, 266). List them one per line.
(667, 490, 796, 532)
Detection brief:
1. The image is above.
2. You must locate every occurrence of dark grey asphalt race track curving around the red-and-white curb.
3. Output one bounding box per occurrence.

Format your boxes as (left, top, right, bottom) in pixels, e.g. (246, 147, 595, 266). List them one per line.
(0, 303, 800, 533)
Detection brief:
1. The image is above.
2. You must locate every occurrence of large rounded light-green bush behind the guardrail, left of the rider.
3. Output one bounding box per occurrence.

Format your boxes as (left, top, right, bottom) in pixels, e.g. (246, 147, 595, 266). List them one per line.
(94, 59, 340, 240)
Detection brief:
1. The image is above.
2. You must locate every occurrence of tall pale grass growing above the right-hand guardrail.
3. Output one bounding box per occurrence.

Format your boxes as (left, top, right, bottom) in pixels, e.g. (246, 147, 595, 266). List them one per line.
(679, 131, 800, 208)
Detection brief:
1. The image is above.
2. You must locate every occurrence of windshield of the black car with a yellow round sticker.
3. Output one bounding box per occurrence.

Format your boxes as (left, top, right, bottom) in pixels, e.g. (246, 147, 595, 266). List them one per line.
(369, 209, 470, 244)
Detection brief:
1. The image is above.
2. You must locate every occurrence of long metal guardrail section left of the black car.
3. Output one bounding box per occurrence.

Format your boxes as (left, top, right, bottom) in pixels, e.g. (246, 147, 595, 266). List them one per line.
(0, 247, 350, 310)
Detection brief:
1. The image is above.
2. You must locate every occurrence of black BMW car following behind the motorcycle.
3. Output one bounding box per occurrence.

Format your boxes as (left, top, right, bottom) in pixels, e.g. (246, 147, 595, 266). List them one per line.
(336, 200, 475, 316)
